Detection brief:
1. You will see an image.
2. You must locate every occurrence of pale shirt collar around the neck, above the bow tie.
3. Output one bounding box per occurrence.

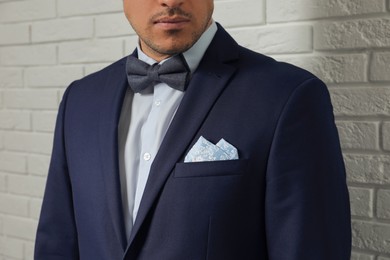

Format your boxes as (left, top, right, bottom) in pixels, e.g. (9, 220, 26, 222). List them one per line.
(137, 21, 218, 73)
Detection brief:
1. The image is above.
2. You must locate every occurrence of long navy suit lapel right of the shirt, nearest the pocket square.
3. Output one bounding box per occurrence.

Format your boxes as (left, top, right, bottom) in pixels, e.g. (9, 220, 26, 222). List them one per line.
(127, 27, 238, 254)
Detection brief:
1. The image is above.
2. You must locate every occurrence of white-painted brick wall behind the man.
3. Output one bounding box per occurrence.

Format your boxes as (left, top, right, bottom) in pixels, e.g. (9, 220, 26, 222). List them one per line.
(0, 0, 390, 260)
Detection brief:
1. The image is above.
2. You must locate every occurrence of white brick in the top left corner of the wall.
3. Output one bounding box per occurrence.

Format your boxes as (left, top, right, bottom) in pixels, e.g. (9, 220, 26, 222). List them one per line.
(0, 0, 56, 22)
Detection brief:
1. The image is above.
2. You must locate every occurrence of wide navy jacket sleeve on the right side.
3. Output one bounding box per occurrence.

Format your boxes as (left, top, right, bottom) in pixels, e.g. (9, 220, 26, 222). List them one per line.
(265, 79, 351, 260)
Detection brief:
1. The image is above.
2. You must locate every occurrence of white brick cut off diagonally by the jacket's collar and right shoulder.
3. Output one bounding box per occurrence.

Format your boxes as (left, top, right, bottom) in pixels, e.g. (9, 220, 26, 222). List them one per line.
(229, 25, 313, 54)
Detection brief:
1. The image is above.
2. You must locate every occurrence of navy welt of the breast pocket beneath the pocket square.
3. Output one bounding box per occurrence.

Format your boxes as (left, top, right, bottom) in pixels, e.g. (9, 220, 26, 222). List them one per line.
(173, 159, 248, 178)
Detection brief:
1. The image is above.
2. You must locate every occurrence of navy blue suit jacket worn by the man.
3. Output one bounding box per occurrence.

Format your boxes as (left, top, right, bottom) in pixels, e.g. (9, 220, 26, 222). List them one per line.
(35, 24, 351, 260)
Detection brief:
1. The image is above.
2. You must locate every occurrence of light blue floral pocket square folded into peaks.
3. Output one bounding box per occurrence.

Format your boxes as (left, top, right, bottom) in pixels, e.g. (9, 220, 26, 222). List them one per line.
(184, 136, 238, 162)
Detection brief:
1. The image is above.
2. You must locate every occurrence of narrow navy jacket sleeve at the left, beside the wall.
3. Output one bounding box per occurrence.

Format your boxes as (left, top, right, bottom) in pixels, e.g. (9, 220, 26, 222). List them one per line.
(34, 84, 79, 260)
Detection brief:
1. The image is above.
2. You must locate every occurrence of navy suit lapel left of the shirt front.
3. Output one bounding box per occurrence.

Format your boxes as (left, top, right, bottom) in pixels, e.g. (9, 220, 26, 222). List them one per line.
(99, 59, 128, 250)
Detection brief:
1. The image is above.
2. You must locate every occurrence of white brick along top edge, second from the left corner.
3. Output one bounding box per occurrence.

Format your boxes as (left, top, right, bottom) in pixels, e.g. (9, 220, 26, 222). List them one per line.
(58, 0, 123, 16)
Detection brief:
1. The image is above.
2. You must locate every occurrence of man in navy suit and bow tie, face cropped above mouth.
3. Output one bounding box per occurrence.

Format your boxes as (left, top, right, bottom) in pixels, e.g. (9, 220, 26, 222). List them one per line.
(35, 0, 350, 260)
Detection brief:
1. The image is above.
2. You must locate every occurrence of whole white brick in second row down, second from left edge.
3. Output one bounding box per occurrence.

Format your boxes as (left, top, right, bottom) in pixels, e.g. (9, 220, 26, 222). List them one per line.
(31, 17, 94, 43)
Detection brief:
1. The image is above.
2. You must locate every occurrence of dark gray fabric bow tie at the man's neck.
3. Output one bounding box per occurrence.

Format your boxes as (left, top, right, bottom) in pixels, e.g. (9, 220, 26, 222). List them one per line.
(126, 54, 190, 93)
